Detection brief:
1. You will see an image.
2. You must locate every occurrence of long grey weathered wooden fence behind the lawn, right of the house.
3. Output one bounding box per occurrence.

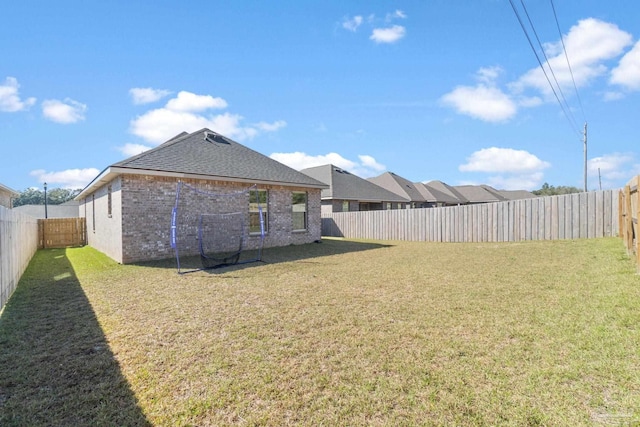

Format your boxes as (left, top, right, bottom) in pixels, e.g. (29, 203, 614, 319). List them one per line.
(322, 190, 619, 242)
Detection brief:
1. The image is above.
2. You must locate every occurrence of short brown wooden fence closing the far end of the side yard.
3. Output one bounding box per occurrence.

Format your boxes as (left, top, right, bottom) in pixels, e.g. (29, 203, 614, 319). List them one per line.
(38, 218, 87, 249)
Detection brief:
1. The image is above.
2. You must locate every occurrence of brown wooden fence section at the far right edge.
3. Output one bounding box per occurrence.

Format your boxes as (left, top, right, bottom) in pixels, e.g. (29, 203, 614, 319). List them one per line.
(618, 175, 640, 270)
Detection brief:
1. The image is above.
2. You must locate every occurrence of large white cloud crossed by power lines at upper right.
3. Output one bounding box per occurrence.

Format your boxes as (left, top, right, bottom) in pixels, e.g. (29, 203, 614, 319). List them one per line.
(510, 18, 632, 99)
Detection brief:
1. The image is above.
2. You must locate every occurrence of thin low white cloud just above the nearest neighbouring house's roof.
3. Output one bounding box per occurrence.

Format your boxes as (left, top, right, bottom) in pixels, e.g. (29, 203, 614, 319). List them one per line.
(269, 151, 386, 178)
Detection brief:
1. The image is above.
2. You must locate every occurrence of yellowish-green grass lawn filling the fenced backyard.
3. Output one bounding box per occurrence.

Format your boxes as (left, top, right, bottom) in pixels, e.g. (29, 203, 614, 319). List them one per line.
(0, 238, 640, 426)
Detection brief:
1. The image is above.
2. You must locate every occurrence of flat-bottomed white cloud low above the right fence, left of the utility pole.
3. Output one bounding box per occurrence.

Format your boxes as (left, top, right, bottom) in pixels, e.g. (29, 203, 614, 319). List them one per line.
(458, 147, 551, 173)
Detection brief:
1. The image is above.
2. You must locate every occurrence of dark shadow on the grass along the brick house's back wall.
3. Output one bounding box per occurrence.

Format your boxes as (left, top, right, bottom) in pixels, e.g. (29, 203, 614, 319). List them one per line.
(133, 238, 393, 274)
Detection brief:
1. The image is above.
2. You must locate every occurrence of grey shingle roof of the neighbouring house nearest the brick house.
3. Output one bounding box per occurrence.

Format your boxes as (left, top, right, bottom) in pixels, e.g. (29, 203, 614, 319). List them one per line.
(300, 165, 409, 203)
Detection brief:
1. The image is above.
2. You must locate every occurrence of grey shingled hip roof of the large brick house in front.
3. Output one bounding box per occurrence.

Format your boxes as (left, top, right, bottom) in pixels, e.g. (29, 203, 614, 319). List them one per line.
(76, 128, 326, 200)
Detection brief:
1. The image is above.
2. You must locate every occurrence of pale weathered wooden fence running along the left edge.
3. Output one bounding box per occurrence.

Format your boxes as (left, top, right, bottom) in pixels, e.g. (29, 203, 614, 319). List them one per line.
(0, 206, 38, 310)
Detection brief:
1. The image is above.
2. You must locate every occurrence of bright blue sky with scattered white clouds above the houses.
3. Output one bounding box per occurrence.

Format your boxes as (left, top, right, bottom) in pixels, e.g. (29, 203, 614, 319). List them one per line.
(0, 0, 640, 191)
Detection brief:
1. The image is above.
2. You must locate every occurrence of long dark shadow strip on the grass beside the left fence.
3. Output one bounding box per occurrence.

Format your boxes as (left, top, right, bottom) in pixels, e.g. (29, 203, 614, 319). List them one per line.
(0, 249, 151, 426)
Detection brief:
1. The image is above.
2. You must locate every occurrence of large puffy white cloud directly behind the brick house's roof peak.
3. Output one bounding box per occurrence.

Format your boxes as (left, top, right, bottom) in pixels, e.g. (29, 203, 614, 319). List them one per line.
(130, 91, 286, 144)
